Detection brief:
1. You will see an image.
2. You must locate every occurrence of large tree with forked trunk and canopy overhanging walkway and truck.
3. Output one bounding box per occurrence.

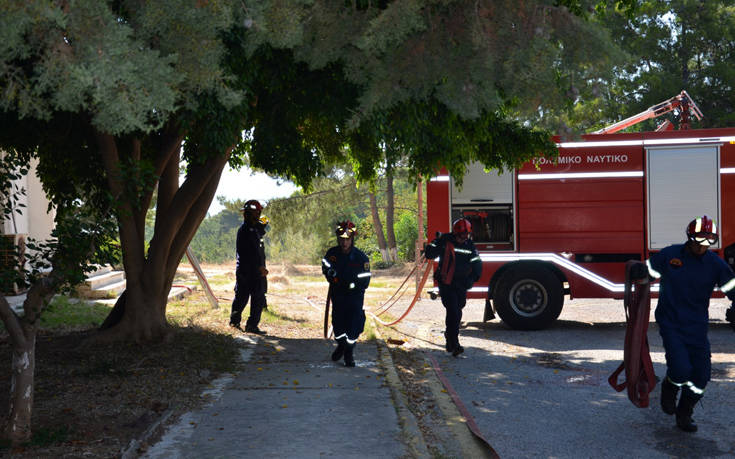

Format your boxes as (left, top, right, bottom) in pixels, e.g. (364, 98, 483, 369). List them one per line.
(0, 0, 624, 340)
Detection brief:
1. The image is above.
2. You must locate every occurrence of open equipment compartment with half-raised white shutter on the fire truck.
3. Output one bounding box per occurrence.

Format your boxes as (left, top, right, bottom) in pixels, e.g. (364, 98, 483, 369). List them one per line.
(451, 162, 515, 250)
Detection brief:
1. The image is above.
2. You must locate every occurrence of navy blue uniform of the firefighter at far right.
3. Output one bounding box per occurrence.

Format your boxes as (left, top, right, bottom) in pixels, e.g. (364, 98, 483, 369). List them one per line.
(647, 244, 735, 394)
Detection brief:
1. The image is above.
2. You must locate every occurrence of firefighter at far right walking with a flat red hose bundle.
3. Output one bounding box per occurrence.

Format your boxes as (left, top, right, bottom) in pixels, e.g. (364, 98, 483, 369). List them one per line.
(646, 215, 735, 432)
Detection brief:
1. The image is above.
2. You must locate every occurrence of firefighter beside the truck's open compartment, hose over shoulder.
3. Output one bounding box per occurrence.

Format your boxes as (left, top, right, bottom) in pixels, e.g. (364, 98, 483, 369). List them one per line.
(424, 218, 482, 357)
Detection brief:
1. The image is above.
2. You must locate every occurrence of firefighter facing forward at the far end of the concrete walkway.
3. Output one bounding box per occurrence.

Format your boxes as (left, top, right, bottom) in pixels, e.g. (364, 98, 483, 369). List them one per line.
(322, 220, 370, 367)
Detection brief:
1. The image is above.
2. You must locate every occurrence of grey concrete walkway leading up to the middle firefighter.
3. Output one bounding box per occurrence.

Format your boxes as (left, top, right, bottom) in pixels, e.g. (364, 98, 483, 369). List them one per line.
(141, 335, 414, 458)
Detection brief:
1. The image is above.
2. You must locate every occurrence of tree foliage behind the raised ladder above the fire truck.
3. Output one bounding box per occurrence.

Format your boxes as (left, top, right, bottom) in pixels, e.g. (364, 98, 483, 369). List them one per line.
(539, 0, 735, 133)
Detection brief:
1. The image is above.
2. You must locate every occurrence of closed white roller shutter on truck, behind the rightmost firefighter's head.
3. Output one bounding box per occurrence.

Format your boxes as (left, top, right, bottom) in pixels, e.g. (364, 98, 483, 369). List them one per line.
(647, 145, 721, 250)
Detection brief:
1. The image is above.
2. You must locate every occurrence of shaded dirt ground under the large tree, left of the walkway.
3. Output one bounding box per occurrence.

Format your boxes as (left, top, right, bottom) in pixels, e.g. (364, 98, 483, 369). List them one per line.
(0, 318, 242, 458)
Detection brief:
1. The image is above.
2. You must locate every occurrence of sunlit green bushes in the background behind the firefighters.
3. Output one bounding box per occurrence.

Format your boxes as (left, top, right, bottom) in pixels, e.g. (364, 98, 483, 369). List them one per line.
(185, 169, 426, 266)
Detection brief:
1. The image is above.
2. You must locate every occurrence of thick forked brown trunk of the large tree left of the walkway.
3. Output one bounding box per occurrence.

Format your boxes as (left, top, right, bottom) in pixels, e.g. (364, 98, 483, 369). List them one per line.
(94, 128, 232, 342)
